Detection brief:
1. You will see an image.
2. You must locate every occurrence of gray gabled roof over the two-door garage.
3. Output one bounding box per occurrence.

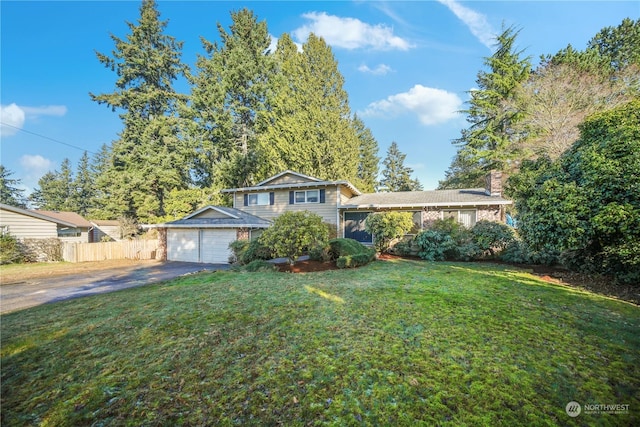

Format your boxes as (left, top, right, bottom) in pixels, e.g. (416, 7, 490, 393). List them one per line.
(160, 205, 271, 228)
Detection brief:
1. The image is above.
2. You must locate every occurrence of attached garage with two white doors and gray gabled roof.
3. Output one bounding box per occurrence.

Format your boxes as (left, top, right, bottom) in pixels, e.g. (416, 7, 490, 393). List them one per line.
(161, 206, 271, 264)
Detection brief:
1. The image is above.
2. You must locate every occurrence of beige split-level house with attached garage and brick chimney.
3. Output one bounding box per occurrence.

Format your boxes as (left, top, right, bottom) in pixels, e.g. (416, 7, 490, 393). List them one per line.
(157, 170, 512, 263)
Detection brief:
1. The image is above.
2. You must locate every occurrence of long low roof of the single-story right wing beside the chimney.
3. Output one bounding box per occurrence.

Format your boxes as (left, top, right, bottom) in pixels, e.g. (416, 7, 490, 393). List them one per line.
(341, 188, 512, 209)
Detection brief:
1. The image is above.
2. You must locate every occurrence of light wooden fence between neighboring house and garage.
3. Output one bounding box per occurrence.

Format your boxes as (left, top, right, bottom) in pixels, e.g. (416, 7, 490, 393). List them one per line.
(62, 240, 158, 262)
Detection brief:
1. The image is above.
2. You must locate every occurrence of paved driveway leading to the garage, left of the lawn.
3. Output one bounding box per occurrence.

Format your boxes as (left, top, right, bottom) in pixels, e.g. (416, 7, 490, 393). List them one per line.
(0, 261, 229, 314)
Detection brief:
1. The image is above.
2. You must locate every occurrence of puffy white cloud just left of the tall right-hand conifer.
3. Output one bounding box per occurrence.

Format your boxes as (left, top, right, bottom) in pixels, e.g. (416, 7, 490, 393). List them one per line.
(362, 85, 462, 126)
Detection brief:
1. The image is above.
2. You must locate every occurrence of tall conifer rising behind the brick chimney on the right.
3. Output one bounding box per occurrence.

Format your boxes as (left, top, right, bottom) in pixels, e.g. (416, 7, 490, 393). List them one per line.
(441, 27, 531, 187)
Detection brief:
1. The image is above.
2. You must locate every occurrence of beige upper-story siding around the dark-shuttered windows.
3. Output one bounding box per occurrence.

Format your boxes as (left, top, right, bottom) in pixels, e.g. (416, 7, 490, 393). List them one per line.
(234, 187, 337, 224)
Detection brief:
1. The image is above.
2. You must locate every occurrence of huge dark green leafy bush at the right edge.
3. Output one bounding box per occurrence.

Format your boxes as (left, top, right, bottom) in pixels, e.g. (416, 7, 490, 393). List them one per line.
(507, 100, 640, 284)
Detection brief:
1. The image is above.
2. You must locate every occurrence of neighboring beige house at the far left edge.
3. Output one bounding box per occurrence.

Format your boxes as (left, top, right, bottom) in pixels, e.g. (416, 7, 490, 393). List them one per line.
(0, 203, 92, 243)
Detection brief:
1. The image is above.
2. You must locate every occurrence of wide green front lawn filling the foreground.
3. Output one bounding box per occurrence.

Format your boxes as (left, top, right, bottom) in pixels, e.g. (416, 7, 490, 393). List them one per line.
(1, 260, 640, 426)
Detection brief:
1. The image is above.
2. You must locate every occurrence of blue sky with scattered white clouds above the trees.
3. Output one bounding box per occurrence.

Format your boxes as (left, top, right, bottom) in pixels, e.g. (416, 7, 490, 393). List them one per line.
(0, 0, 640, 192)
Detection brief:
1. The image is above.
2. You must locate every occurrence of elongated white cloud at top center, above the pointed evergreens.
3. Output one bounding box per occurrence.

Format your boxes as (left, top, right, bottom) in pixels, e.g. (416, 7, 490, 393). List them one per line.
(292, 12, 413, 50)
